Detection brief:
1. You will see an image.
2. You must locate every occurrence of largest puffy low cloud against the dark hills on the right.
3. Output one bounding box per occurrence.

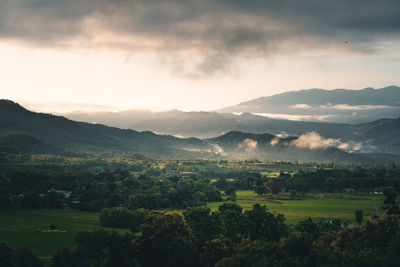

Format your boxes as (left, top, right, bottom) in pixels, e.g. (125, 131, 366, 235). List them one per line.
(290, 132, 362, 152)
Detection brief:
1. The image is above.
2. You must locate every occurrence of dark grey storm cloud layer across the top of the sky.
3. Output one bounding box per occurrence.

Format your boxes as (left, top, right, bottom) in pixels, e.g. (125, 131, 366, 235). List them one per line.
(0, 0, 400, 72)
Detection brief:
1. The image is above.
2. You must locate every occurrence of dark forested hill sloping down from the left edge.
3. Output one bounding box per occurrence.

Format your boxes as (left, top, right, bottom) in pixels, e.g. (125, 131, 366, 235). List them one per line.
(0, 100, 205, 156)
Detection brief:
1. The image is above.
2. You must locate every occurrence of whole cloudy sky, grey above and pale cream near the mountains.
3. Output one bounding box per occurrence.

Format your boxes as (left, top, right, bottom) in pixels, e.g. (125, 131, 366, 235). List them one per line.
(0, 0, 400, 111)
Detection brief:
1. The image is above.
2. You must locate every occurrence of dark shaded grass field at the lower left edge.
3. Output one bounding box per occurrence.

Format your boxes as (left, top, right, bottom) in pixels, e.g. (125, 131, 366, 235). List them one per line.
(0, 209, 126, 260)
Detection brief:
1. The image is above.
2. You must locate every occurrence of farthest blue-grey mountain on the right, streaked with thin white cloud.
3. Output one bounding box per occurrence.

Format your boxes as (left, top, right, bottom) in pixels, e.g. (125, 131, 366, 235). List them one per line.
(218, 86, 400, 123)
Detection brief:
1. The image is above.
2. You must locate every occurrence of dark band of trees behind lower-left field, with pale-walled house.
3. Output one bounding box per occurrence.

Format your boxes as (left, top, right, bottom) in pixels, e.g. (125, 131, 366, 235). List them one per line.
(0, 170, 221, 211)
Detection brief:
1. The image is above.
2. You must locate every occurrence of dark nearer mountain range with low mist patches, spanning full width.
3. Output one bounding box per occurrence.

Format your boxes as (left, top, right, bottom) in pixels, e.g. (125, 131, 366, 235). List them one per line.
(0, 100, 400, 162)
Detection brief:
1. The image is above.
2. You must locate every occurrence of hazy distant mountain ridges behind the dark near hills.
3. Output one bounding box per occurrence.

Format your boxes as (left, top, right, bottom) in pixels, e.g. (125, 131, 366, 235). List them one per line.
(57, 86, 400, 154)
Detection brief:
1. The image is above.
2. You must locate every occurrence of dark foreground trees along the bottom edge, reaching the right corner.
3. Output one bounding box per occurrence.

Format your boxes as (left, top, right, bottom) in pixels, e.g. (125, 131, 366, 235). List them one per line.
(0, 203, 400, 267)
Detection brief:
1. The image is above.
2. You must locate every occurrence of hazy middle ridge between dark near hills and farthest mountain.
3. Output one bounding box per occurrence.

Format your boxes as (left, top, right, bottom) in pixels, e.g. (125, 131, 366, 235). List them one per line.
(63, 108, 400, 154)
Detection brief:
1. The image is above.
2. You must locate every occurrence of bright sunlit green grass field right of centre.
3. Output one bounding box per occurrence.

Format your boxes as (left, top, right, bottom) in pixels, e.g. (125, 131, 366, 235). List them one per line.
(207, 190, 383, 224)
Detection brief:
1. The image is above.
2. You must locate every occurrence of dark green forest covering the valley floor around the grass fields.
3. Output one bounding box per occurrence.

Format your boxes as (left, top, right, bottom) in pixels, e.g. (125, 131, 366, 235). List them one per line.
(0, 153, 400, 267)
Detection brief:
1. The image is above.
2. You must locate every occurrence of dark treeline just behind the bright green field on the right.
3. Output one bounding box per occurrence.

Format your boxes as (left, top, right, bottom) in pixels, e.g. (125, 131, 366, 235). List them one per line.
(215, 166, 400, 194)
